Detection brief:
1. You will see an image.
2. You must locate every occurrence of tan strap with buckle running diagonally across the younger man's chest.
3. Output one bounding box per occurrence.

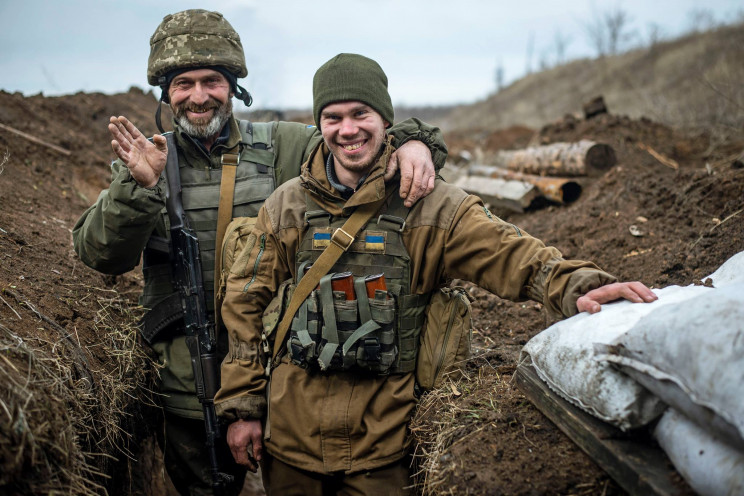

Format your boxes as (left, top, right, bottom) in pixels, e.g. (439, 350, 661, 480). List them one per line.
(272, 197, 385, 358)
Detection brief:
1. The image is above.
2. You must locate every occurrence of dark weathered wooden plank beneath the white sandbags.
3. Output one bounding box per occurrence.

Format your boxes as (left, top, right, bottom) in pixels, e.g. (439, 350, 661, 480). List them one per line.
(515, 363, 695, 496)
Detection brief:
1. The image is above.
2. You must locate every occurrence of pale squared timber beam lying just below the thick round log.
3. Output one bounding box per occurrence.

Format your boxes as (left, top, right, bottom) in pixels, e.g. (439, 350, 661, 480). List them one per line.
(454, 176, 539, 212)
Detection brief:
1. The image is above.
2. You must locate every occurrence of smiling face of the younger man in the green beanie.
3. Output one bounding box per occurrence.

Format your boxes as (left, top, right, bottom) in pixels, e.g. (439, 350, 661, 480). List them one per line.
(319, 101, 388, 187)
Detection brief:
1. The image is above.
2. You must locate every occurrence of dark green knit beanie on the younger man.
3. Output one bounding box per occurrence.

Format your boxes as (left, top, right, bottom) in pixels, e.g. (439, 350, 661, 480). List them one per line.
(313, 53, 394, 127)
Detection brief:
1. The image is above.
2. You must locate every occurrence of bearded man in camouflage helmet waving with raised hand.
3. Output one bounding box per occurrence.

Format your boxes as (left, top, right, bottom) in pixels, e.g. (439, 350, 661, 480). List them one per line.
(73, 9, 447, 494)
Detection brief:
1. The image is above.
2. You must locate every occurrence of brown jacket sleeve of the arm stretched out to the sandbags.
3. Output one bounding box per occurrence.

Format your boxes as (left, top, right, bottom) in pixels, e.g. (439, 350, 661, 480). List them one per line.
(444, 196, 617, 317)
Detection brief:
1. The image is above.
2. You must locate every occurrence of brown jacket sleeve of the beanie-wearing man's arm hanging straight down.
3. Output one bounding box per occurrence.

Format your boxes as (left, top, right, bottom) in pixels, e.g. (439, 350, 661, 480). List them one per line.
(215, 200, 291, 421)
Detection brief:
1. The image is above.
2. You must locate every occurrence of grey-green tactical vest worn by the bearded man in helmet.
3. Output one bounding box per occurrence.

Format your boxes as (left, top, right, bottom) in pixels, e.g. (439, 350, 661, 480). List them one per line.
(140, 121, 276, 331)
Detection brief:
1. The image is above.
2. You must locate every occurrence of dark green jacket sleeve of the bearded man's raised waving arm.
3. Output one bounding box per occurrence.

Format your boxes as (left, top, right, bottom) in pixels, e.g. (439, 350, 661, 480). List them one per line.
(72, 160, 165, 274)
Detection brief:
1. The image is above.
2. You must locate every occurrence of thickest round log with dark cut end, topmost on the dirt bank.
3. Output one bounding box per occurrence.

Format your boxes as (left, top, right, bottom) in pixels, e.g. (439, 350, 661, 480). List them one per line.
(494, 140, 617, 177)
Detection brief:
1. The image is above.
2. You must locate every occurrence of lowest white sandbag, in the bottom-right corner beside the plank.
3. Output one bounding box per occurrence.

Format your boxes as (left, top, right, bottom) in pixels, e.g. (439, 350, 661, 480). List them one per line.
(654, 408, 744, 496)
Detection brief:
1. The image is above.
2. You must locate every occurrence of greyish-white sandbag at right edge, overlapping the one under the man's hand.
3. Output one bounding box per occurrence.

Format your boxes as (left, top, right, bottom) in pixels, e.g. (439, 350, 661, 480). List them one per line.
(597, 283, 744, 452)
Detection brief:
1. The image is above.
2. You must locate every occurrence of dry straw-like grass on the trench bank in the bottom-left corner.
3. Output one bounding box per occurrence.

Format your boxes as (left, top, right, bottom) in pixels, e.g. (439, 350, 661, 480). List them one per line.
(0, 287, 154, 495)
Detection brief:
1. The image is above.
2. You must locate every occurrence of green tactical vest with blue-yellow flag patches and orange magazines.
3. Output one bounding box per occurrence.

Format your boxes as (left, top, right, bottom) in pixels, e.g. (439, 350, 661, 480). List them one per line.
(287, 194, 429, 375)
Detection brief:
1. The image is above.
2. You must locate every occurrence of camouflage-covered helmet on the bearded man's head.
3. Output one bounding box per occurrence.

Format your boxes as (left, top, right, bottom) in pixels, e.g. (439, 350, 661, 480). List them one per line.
(147, 9, 248, 86)
